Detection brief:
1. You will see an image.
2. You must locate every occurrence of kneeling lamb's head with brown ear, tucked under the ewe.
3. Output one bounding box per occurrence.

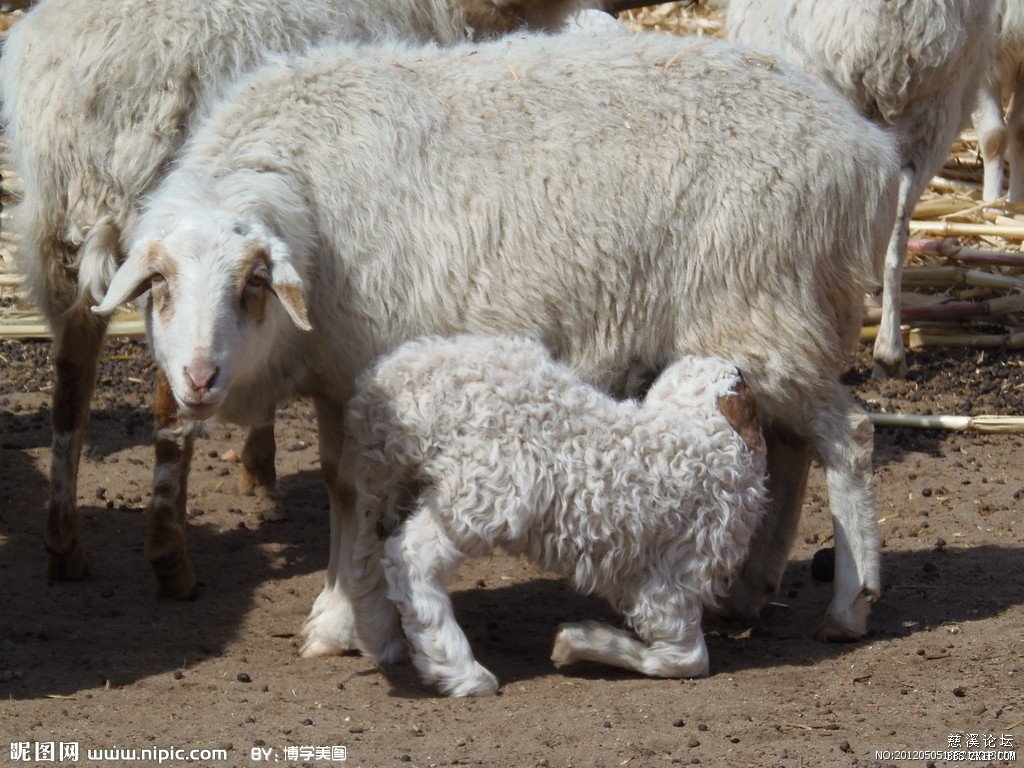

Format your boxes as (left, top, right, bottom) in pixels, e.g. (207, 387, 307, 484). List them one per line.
(644, 355, 765, 451)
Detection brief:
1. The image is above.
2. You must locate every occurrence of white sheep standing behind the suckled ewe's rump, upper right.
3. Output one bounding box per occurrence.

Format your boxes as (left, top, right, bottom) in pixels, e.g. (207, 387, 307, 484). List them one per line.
(725, 0, 993, 376)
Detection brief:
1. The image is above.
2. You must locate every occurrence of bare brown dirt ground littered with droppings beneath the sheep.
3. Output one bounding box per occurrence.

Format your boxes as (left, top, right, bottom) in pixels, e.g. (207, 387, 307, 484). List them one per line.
(0, 341, 1024, 767)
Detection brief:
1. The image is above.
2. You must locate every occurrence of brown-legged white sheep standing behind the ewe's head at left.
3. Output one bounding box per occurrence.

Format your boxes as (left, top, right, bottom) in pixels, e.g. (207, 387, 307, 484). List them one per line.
(2, 0, 589, 597)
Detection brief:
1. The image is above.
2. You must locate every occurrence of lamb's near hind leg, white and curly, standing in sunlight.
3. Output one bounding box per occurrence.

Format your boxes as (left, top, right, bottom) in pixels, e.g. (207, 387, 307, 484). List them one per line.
(384, 512, 498, 696)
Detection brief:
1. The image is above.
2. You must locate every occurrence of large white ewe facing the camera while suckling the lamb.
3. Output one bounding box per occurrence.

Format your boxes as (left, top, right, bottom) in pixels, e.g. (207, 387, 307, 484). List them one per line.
(96, 35, 896, 654)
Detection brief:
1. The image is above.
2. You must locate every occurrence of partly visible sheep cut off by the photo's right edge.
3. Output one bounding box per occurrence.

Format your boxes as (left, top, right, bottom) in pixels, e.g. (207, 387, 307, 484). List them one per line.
(974, 0, 1024, 203)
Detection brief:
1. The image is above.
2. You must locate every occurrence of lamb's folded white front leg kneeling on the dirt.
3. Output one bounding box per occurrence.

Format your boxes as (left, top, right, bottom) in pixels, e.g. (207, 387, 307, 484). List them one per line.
(551, 591, 709, 677)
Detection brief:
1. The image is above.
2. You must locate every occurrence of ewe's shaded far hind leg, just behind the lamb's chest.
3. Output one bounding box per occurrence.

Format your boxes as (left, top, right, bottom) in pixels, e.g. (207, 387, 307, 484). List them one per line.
(719, 424, 812, 623)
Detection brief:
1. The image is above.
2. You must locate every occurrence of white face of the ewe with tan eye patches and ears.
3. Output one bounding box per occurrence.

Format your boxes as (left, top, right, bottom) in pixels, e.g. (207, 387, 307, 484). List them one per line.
(93, 209, 310, 419)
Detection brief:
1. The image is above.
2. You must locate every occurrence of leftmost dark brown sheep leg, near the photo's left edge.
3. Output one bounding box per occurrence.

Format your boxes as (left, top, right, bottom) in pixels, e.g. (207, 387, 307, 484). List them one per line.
(44, 310, 106, 581)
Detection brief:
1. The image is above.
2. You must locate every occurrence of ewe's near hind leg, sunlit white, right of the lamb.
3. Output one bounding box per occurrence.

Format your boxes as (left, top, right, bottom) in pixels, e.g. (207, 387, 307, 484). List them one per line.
(805, 383, 881, 640)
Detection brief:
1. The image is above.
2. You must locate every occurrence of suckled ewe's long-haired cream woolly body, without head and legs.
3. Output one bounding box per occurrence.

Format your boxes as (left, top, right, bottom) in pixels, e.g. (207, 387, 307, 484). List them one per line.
(134, 31, 893, 421)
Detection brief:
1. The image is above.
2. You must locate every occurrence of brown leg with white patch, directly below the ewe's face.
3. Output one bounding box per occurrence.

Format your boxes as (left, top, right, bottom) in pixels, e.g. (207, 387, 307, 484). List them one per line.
(145, 370, 198, 600)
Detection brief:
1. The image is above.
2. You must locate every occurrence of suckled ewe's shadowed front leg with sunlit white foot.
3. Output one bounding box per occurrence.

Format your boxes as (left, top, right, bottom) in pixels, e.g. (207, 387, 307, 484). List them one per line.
(300, 397, 358, 658)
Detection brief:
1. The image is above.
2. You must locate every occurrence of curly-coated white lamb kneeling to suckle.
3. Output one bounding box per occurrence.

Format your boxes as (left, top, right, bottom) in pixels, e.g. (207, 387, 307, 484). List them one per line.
(345, 336, 767, 696)
